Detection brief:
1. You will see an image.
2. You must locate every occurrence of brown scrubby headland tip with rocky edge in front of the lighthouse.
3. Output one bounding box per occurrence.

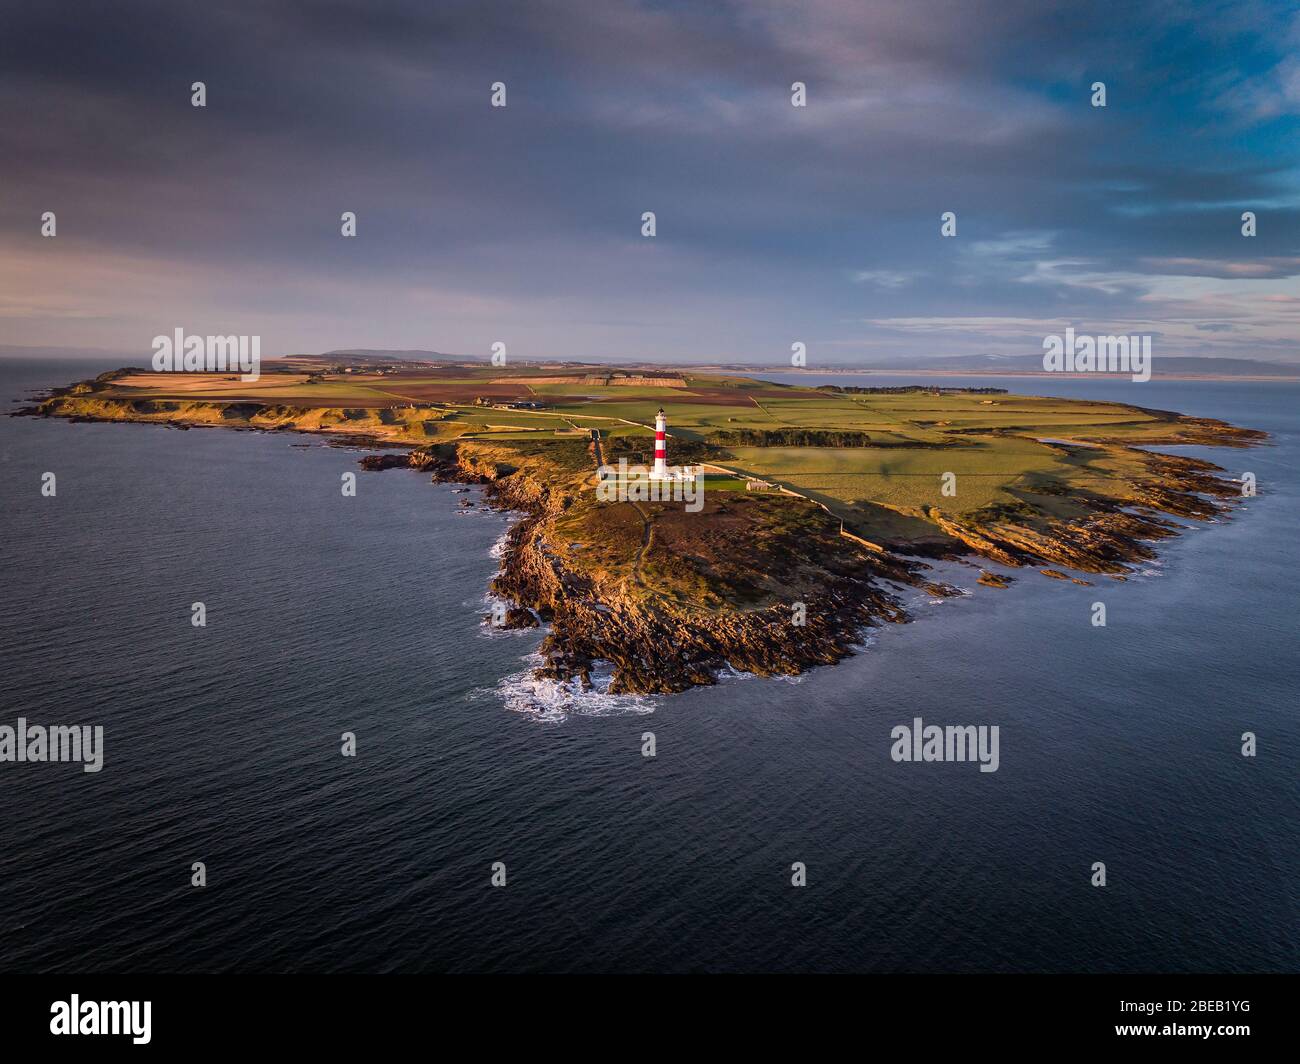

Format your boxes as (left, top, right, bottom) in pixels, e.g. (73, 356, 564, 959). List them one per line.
(377, 442, 957, 693)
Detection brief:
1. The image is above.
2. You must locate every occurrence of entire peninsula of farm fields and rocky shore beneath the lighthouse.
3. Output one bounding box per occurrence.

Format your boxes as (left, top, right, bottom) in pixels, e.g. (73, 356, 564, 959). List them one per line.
(18, 356, 1265, 692)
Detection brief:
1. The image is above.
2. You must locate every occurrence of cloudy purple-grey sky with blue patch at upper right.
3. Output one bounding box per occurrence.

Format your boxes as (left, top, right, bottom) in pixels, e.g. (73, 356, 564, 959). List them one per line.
(0, 0, 1300, 366)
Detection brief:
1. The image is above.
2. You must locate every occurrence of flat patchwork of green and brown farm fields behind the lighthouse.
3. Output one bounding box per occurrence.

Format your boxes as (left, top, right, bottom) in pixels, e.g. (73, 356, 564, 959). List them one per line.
(86, 359, 1242, 531)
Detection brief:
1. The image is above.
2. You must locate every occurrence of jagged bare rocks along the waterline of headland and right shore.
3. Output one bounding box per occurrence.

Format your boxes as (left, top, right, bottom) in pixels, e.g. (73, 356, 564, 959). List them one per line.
(351, 426, 1239, 693)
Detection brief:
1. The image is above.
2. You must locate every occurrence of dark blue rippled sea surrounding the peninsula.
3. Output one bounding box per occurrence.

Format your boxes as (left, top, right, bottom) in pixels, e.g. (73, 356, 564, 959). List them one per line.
(0, 362, 1300, 972)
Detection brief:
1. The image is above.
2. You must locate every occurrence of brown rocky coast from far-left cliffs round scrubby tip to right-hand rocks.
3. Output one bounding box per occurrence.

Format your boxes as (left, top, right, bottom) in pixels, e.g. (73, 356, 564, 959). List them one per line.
(16, 382, 1264, 693)
